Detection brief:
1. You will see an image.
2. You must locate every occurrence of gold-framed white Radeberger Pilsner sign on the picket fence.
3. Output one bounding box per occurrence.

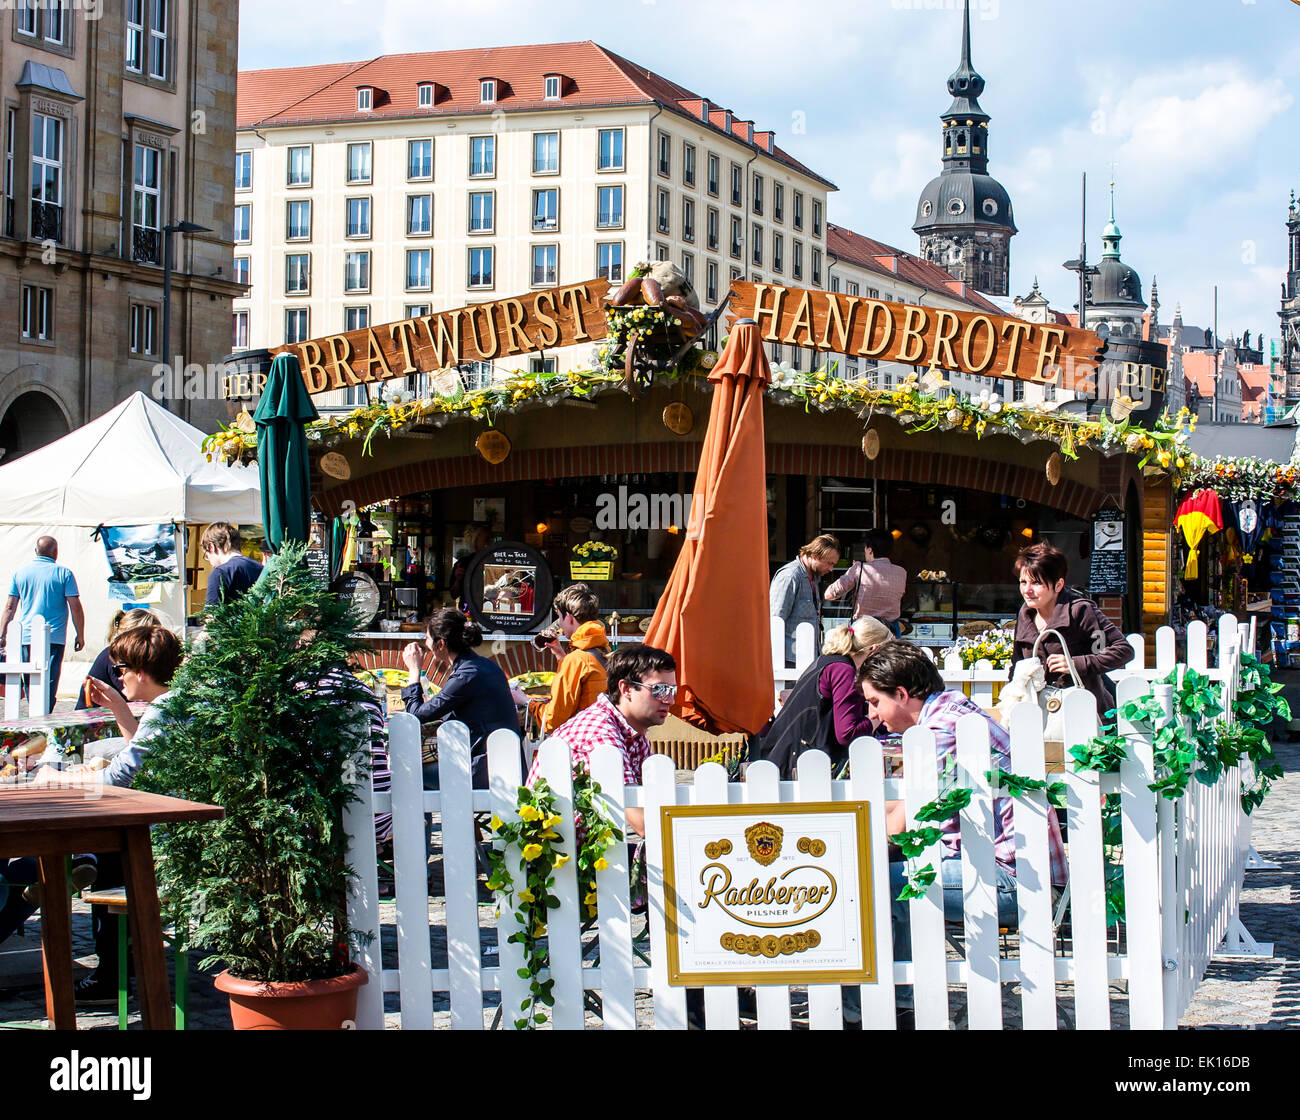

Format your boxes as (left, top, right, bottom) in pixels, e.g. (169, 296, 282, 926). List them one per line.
(660, 802, 876, 987)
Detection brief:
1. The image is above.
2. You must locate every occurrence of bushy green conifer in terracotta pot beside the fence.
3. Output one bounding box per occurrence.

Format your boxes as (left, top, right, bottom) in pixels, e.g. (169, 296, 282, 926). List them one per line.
(135, 546, 369, 1029)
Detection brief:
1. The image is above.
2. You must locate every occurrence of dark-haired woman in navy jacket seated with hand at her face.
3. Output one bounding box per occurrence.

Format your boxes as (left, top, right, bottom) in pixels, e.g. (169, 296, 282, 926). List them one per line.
(402, 607, 519, 790)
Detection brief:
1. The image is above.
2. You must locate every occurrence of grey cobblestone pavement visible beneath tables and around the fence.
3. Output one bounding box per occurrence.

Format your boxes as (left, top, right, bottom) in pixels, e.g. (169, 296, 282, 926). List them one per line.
(0, 743, 1300, 1030)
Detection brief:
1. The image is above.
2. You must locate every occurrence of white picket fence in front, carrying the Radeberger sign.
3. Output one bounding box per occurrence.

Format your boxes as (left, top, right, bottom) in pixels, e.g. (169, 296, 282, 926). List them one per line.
(346, 657, 1263, 1029)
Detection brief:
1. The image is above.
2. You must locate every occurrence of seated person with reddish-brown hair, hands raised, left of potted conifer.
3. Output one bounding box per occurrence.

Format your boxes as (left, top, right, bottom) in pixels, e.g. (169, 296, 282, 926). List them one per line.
(34, 626, 181, 1004)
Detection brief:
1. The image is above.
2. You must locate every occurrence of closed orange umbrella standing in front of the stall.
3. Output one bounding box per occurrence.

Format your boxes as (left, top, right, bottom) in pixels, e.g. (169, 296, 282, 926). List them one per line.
(646, 318, 774, 734)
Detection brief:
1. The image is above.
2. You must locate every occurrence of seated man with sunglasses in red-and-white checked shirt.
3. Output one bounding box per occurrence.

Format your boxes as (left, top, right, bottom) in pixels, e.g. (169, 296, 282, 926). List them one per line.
(528, 643, 677, 835)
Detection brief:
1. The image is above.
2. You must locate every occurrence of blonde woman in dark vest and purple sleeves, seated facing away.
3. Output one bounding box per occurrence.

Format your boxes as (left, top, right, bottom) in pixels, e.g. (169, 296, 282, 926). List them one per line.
(750, 615, 889, 778)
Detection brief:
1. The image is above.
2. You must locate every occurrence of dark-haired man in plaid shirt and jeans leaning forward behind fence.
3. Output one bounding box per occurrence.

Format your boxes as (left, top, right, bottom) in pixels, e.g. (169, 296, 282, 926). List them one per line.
(858, 641, 1066, 1003)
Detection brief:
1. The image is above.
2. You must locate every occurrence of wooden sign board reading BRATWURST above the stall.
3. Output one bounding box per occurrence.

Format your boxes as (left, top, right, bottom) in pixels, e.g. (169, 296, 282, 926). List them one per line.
(276, 279, 610, 392)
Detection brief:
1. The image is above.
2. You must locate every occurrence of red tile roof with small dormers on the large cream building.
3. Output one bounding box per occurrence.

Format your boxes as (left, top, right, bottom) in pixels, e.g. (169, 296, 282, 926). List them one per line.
(237, 42, 836, 191)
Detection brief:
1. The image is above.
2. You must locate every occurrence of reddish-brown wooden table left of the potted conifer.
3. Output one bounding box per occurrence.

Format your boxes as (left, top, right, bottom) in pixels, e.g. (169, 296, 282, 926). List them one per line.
(0, 786, 225, 1030)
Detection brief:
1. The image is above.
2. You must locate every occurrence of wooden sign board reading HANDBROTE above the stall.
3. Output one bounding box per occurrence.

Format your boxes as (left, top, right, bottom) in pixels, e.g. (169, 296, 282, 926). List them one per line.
(731, 281, 1102, 391)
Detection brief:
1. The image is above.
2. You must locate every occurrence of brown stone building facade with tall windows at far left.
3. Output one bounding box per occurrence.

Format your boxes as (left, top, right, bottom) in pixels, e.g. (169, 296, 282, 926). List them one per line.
(0, 0, 241, 461)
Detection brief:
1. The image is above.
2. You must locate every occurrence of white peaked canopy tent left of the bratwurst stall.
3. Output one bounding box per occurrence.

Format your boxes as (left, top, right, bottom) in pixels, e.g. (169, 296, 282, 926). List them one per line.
(0, 392, 261, 695)
